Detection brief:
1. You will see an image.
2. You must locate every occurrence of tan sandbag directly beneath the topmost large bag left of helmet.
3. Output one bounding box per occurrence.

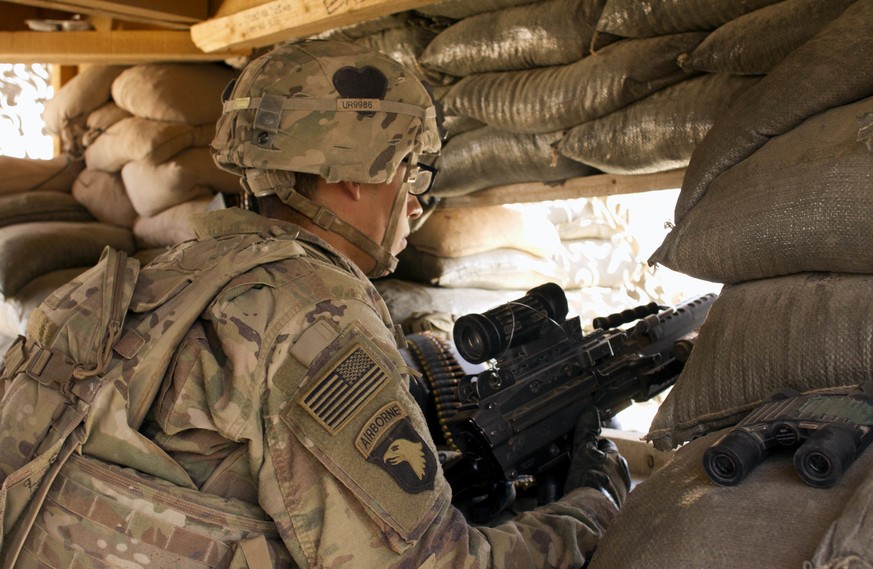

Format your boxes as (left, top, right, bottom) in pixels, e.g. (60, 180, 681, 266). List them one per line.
(85, 116, 195, 172)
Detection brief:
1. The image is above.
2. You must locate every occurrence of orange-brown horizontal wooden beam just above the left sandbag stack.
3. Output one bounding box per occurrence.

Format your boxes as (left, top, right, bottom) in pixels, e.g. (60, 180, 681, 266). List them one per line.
(0, 30, 249, 65)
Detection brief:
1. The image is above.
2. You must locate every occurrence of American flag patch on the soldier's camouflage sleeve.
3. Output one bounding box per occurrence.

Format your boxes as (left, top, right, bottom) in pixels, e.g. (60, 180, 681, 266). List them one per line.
(300, 345, 388, 435)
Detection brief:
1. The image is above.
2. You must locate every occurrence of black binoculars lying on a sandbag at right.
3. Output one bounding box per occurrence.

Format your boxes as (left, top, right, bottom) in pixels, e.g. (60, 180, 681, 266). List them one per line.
(703, 382, 873, 488)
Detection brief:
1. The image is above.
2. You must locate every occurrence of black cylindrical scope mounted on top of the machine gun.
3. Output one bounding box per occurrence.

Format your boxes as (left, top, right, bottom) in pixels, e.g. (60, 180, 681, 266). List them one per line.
(452, 283, 568, 364)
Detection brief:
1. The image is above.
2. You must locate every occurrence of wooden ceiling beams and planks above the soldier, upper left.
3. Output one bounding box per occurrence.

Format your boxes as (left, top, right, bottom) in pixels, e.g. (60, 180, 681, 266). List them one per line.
(0, 0, 434, 65)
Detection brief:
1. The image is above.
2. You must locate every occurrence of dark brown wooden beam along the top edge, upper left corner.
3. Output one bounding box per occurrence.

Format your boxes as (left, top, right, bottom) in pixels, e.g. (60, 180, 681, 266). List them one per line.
(7, 0, 209, 29)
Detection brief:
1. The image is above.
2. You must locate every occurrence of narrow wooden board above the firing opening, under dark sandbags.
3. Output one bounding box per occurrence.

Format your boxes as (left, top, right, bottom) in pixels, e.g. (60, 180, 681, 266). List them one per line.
(440, 169, 685, 208)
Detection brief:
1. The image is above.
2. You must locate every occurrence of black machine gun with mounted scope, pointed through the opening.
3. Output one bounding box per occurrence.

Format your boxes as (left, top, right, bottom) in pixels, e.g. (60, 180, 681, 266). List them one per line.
(436, 283, 716, 523)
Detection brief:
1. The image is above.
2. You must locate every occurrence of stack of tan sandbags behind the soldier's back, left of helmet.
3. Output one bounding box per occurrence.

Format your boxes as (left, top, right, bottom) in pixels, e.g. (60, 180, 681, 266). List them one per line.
(0, 64, 239, 337)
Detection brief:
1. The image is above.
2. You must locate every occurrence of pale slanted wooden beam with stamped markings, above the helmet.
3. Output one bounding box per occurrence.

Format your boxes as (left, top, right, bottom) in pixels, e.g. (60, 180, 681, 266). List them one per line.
(191, 0, 435, 52)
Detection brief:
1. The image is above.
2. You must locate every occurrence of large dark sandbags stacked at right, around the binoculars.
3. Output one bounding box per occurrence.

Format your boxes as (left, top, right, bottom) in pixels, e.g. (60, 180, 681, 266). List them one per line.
(591, 0, 873, 569)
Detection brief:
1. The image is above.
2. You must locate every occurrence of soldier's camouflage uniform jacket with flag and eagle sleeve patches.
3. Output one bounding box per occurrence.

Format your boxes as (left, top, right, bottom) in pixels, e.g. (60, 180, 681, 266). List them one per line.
(145, 205, 616, 568)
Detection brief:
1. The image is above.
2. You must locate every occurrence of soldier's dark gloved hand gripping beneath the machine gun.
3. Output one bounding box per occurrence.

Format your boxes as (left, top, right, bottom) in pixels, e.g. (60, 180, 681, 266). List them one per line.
(564, 407, 630, 507)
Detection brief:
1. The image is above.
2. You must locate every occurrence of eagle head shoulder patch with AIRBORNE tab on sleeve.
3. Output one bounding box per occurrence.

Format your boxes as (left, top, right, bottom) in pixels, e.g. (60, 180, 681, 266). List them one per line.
(355, 401, 436, 494)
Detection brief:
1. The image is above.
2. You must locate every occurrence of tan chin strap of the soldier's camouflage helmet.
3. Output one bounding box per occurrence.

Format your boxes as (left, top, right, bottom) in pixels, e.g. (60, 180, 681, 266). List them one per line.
(243, 169, 407, 278)
